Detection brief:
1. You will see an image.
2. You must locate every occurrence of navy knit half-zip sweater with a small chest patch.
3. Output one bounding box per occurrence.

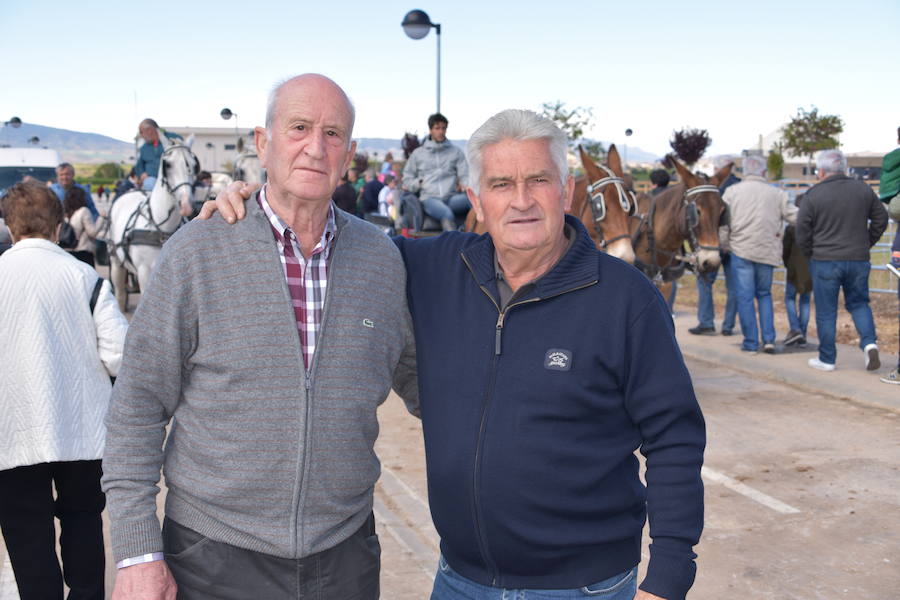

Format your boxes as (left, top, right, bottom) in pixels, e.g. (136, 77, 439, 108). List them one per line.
(397, 216, 705, 600)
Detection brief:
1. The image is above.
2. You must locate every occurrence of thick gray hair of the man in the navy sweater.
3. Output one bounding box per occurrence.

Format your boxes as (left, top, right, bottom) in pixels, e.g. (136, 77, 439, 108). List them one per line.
(466, 108, 569, 194)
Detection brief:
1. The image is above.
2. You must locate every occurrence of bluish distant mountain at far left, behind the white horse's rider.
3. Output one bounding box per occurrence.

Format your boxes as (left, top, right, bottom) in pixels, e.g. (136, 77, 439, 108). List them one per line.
(0, 123, 134, 164)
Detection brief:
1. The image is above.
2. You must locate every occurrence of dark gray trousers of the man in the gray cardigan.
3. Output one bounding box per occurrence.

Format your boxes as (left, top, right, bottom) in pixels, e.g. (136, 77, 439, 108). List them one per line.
(163, 515, 381, 600)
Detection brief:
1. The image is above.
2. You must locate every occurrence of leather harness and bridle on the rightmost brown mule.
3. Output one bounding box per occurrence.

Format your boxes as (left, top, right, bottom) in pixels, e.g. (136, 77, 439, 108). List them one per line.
(631, 184, 719, 281)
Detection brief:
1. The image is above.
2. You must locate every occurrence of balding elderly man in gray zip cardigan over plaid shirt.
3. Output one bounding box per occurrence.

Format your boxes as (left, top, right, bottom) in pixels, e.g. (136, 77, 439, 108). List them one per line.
(103, 74, 416, 599)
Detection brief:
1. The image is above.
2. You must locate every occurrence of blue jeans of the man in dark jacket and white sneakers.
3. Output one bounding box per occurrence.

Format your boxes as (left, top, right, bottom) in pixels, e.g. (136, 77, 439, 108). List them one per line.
(809, 260, 876, 365)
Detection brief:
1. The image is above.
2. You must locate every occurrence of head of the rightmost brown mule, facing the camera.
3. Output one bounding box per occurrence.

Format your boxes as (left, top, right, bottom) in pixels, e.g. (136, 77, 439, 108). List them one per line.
(668, 156, 731, 272)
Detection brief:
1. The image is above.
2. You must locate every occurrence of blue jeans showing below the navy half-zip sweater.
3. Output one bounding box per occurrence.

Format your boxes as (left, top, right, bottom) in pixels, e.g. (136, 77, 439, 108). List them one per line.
(431, 556, 637, 600)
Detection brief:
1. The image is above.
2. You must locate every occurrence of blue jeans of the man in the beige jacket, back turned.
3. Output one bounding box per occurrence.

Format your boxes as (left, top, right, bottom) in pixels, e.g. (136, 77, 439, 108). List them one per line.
(731, 254, 775, 352)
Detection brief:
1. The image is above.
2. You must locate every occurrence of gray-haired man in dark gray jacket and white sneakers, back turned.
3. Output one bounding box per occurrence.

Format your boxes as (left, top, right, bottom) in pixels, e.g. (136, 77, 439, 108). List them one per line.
(797, 150, 888, 371)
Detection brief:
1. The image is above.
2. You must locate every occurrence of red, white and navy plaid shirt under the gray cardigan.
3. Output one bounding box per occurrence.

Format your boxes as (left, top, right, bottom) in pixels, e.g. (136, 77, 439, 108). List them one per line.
(259, 186, 337, 370)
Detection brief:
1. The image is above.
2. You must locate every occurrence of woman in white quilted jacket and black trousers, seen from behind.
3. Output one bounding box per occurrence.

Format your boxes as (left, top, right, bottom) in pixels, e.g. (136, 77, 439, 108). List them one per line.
(0, 183, 128, 599)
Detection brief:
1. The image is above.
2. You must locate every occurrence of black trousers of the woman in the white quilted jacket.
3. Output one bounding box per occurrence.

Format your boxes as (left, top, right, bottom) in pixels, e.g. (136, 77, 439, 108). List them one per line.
(0, 460, 106, 600)
